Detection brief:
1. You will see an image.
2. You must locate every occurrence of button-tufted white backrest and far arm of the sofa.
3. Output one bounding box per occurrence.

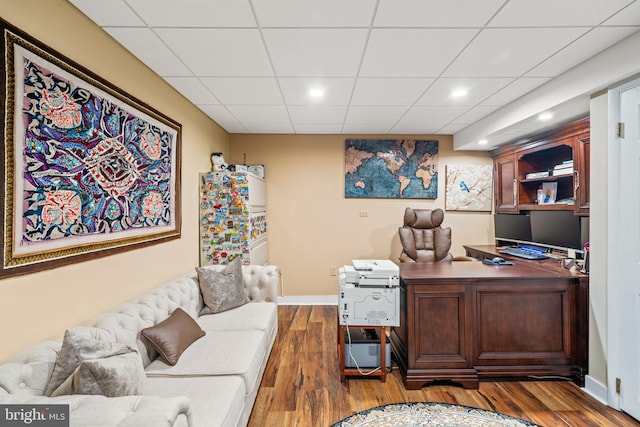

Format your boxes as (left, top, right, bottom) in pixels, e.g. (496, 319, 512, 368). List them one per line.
(0, 265, 278, 398)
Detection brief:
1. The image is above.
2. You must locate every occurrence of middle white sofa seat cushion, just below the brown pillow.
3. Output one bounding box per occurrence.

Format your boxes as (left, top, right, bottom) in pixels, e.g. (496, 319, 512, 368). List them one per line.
(145, 332, 268, 391)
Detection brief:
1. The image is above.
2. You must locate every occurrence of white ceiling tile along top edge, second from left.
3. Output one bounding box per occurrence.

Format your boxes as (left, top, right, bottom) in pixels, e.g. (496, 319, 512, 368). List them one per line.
(125, 0, 256, 27)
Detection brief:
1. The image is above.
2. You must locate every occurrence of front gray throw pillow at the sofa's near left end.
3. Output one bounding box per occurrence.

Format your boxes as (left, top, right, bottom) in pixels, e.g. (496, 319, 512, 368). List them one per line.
(51, 351, 146, 397)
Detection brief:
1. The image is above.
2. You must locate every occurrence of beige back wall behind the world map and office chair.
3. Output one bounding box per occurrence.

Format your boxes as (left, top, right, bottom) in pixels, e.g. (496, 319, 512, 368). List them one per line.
(227, 134, 493, 296)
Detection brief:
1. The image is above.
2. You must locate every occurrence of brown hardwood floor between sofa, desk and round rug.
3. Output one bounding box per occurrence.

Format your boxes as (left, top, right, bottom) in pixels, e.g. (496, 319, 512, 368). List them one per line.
(249, 305, 640, 427)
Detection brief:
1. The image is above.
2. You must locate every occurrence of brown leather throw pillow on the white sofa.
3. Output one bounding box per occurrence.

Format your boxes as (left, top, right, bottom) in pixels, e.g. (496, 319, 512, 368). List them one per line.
(140, 307, 205, 366)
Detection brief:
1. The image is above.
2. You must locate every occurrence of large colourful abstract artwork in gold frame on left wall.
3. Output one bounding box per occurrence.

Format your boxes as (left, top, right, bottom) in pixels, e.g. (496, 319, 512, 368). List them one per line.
(0, 20, 181, 278)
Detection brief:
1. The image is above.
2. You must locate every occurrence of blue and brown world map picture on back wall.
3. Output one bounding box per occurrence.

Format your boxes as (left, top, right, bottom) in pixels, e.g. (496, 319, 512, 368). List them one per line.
(344, 139, 438, 199)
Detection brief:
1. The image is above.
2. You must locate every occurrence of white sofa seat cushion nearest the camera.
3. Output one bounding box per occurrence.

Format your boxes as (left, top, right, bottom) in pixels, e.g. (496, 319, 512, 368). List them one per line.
(144, 375, 246, 427)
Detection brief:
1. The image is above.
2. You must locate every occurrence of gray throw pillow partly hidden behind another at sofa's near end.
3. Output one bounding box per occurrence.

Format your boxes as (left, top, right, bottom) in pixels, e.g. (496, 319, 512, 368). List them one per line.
(44, 327, 142, 396)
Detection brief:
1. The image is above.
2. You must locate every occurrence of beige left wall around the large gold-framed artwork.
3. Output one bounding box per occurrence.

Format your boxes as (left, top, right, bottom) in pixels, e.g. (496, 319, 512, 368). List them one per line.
(0, 0, 229, 362)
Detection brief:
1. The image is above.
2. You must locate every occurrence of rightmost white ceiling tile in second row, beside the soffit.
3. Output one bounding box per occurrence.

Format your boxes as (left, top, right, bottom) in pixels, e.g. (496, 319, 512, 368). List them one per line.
(526, 27, 638, 77)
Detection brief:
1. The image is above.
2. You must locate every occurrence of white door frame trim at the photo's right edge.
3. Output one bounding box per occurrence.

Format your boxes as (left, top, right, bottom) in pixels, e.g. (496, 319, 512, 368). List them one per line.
(606, 78, 640, 410)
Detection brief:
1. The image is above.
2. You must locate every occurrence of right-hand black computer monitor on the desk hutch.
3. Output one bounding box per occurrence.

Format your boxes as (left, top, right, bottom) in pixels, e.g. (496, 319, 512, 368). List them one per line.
(529, 211, 582, 251)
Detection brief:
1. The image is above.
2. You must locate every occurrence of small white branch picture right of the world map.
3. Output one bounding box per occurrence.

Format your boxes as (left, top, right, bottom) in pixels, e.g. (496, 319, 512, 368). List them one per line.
(445, 165, 493, 212)
